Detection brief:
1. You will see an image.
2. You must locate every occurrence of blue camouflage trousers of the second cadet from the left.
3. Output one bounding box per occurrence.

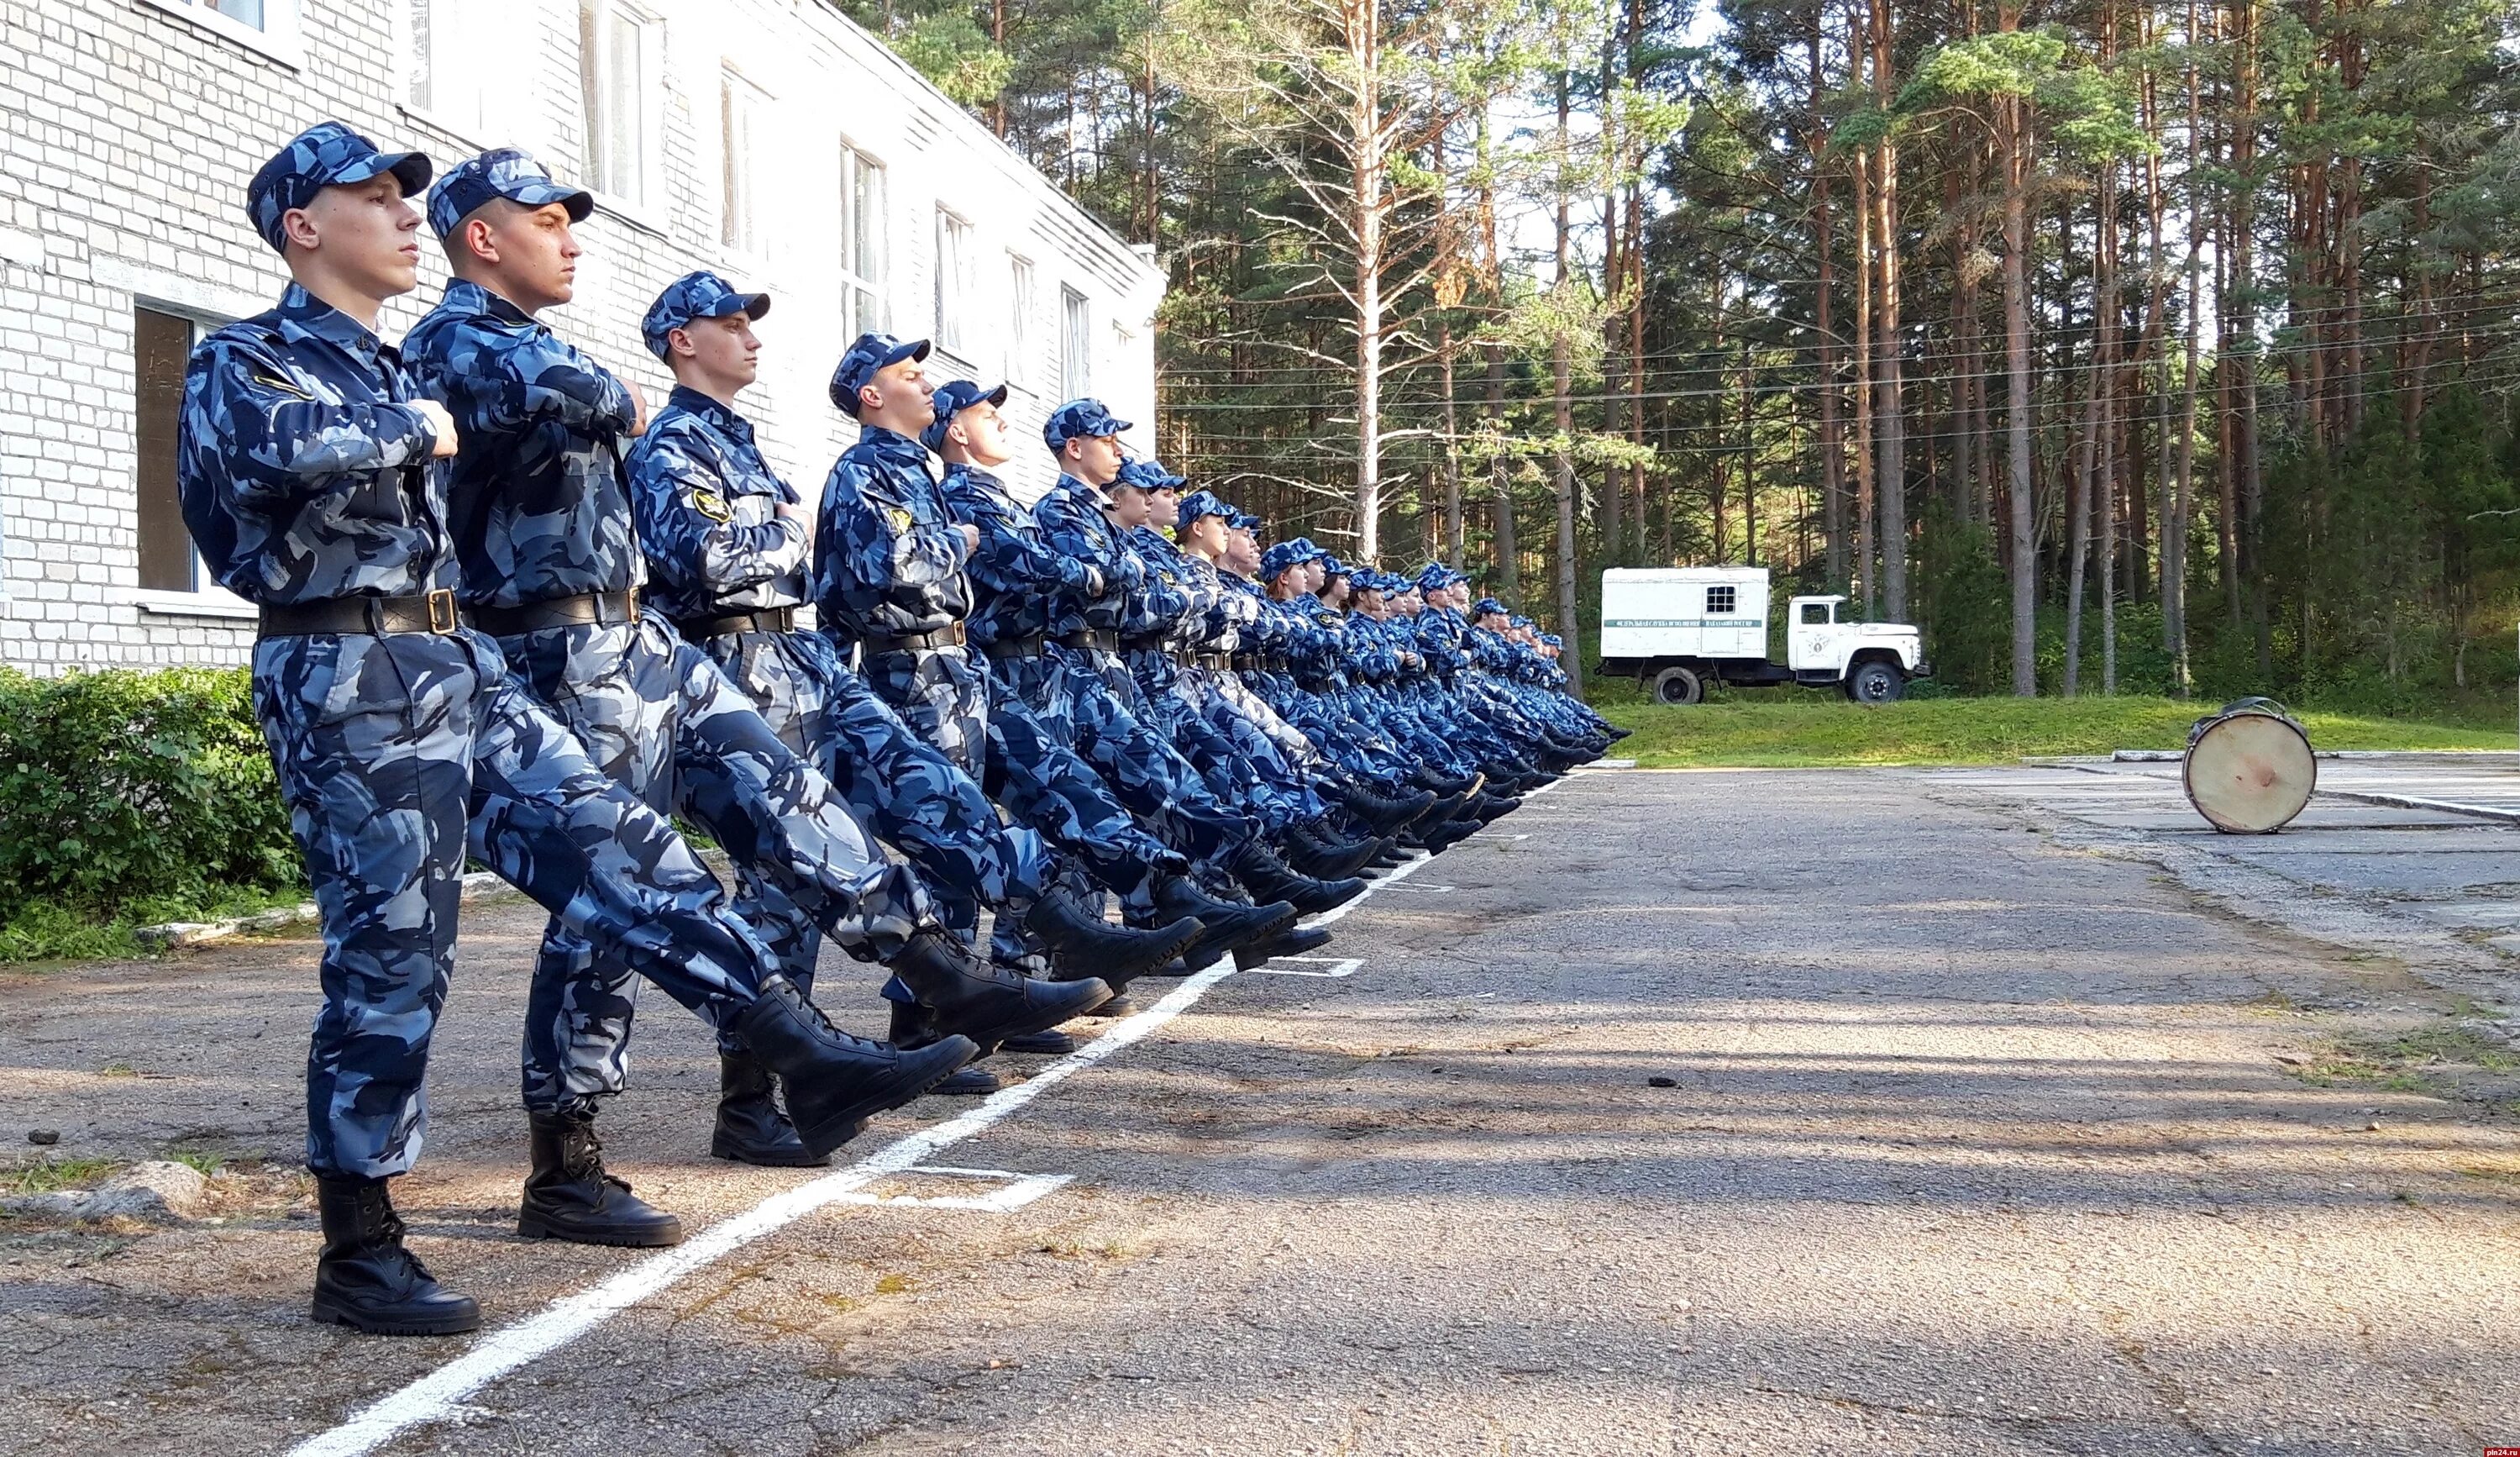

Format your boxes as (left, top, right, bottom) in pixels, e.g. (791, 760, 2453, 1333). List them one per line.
(501, 613, 935, 1109)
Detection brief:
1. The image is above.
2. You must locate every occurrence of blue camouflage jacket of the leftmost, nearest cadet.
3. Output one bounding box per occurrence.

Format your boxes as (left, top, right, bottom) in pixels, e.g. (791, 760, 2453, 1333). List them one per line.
(174, 282, 454, 605)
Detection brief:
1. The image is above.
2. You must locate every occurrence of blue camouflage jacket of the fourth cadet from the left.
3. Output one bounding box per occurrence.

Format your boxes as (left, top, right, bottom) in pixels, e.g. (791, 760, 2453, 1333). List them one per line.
(814, 426, 970, 638)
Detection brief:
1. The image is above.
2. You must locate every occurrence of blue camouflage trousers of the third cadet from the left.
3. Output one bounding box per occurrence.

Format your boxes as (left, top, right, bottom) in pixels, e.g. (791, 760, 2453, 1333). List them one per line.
(701, 633, 1053, 981)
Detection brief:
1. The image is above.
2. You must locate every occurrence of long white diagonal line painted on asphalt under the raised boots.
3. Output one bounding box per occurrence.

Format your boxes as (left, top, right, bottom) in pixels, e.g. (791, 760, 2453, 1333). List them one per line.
(287, 837, 1434, 1457)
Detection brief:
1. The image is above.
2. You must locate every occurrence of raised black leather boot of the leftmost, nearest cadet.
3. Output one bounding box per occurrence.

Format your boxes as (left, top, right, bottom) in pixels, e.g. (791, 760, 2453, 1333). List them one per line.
(733, 976, 980, 1155)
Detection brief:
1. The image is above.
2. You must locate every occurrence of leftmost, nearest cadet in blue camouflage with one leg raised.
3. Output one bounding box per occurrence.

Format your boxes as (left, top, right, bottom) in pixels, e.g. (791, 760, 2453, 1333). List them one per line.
(176, 121, 978, 1333)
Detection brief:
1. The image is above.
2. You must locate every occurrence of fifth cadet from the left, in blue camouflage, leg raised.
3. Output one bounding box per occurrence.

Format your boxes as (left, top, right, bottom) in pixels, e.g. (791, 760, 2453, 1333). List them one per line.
(920, 381, 1295, 970)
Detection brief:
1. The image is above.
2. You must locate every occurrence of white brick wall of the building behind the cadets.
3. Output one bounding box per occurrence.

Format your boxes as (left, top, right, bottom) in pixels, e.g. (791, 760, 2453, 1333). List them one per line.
(0, 0, 1162, 673)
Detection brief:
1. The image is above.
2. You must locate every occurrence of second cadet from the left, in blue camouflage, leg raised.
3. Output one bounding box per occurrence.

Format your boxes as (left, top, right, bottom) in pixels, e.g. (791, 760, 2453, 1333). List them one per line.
(406, 149, 1109, 1215)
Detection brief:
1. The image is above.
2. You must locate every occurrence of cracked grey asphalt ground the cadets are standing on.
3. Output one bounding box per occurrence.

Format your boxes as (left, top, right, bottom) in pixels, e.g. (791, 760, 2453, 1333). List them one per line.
(0, 771, 2520, 1457)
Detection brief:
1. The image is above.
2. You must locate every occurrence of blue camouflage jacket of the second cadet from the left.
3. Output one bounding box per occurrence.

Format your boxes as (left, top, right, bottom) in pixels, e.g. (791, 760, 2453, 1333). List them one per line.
(403, 280, 648, 608)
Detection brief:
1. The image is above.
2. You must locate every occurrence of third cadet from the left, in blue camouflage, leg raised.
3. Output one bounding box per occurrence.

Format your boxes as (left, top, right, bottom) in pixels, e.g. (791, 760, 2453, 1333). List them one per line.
(625, 286, 1197, 1099)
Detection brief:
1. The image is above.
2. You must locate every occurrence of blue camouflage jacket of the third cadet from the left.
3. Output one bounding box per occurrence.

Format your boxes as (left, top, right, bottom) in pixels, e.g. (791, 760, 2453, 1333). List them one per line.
(622, 386, 806, 618)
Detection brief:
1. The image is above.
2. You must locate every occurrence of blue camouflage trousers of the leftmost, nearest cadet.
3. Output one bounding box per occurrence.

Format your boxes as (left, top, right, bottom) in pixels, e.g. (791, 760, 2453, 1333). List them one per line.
(255, 633, 771, 1177)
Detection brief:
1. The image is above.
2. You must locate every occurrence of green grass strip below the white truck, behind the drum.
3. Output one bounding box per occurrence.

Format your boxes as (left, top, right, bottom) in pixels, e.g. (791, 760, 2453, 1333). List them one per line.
(1600, 688, 2515, 769)
